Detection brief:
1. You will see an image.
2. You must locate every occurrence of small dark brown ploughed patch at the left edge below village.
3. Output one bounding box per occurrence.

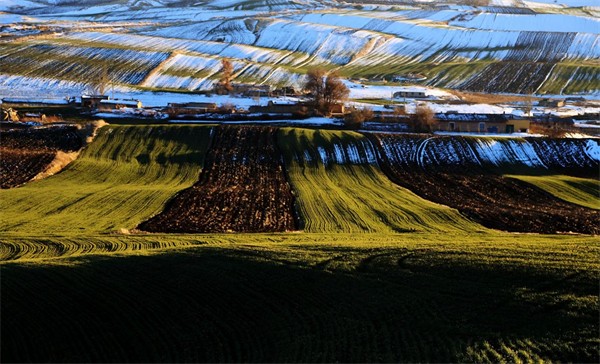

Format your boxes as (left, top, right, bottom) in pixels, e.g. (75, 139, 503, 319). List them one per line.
(0, 127, 83, 188)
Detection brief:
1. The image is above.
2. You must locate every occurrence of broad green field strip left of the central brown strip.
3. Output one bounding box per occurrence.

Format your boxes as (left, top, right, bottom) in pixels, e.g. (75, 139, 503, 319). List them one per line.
(0, 126, 210, 236)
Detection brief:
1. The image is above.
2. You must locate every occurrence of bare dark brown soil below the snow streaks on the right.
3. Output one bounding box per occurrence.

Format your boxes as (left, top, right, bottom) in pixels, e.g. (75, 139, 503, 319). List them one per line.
(371, 135, 600, 234)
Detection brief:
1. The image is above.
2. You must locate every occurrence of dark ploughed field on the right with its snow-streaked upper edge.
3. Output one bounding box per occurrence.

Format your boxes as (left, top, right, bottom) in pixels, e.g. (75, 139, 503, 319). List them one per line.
(374, 134, 600, 234)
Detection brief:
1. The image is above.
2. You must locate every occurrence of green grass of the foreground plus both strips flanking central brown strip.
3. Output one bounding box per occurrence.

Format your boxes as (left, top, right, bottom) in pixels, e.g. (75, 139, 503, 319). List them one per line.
(0, 125, 600, 363)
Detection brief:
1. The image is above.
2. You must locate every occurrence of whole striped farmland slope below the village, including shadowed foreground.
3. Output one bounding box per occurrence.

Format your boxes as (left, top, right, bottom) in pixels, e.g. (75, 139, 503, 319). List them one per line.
(0, 125, 600, 362)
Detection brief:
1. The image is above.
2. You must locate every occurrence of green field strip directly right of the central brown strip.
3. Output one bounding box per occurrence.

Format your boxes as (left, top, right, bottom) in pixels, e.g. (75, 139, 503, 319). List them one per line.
(279, 129, 486, 233)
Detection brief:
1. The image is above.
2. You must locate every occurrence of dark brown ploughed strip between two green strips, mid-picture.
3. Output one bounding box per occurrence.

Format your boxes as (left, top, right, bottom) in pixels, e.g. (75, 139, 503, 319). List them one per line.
(139, 126, 297, 233)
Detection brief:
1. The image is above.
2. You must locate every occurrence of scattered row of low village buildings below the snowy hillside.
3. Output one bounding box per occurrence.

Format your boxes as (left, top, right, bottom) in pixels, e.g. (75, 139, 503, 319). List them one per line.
(2, 93, 596, 133)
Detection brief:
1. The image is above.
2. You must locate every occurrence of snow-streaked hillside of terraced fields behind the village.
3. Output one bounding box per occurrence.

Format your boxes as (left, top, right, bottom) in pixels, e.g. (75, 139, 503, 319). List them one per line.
(0, 0, 600, 94)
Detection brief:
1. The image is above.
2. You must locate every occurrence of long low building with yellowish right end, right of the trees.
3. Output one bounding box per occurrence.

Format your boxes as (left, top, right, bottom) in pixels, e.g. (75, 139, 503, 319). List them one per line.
(435, 113, 529, 134)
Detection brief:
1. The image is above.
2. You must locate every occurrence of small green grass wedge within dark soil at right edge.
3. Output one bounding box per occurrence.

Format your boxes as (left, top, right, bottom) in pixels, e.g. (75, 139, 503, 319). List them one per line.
(506, 175, 600, 210)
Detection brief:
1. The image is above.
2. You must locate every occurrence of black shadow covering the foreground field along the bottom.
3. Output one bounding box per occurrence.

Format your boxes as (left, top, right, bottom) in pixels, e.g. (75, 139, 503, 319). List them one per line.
(1, 248, 598, 362)
